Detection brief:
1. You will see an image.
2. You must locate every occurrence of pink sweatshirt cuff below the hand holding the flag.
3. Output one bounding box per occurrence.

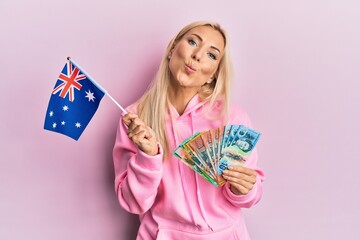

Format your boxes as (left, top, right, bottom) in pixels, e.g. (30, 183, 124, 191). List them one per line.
(135, 143, 163, 170)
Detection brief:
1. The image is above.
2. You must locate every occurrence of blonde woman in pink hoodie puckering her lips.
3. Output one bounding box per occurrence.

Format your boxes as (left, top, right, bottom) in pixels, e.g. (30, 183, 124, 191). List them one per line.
(113, 22, 263, 240)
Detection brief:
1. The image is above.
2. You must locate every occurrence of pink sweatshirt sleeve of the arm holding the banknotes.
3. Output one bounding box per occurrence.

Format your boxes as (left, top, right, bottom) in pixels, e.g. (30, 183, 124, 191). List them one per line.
(223, 105, 265, 208)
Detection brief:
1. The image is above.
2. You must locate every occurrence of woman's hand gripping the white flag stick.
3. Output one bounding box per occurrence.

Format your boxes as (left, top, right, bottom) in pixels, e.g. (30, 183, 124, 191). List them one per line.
(123, 113, 159, 156)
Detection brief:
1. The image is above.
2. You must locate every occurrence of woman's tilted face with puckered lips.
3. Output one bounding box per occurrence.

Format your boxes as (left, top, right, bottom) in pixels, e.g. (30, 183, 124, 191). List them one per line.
(169, 26, 225, 91)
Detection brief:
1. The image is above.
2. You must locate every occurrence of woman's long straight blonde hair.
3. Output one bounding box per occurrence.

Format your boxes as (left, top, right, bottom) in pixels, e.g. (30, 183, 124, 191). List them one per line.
(138, 21, 232, 157)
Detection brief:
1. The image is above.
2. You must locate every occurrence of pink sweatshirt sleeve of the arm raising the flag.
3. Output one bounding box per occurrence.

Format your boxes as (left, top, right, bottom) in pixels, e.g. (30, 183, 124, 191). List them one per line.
(113, 118, 163, 214)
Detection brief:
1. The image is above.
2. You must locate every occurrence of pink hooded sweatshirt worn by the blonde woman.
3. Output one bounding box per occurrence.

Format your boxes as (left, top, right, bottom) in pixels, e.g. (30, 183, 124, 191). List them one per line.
(113, 96, 264, 240)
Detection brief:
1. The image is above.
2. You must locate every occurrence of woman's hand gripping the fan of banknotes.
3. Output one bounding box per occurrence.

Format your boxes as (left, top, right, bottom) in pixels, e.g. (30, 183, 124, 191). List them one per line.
(222, 166, 257, 195)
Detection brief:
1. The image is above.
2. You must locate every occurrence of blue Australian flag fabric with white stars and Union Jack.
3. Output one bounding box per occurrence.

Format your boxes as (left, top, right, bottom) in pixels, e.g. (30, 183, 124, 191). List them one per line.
(44, 61, 105, 140)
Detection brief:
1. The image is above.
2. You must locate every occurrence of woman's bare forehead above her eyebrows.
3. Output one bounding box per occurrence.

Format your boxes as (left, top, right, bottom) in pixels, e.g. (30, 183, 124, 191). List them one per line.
(184, 26, 225, 50)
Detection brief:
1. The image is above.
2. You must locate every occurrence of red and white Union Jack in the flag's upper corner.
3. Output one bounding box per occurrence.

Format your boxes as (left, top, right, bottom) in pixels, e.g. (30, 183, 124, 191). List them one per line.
(53, 61, 86, 102)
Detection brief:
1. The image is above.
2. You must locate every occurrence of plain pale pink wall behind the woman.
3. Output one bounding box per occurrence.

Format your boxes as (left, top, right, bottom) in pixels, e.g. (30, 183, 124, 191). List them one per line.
(0, 0, 360, 240)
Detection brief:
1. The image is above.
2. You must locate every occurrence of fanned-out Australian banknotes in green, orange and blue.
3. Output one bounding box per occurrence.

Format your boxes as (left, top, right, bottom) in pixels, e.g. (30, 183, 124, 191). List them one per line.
(174, 125, 261, 186)
